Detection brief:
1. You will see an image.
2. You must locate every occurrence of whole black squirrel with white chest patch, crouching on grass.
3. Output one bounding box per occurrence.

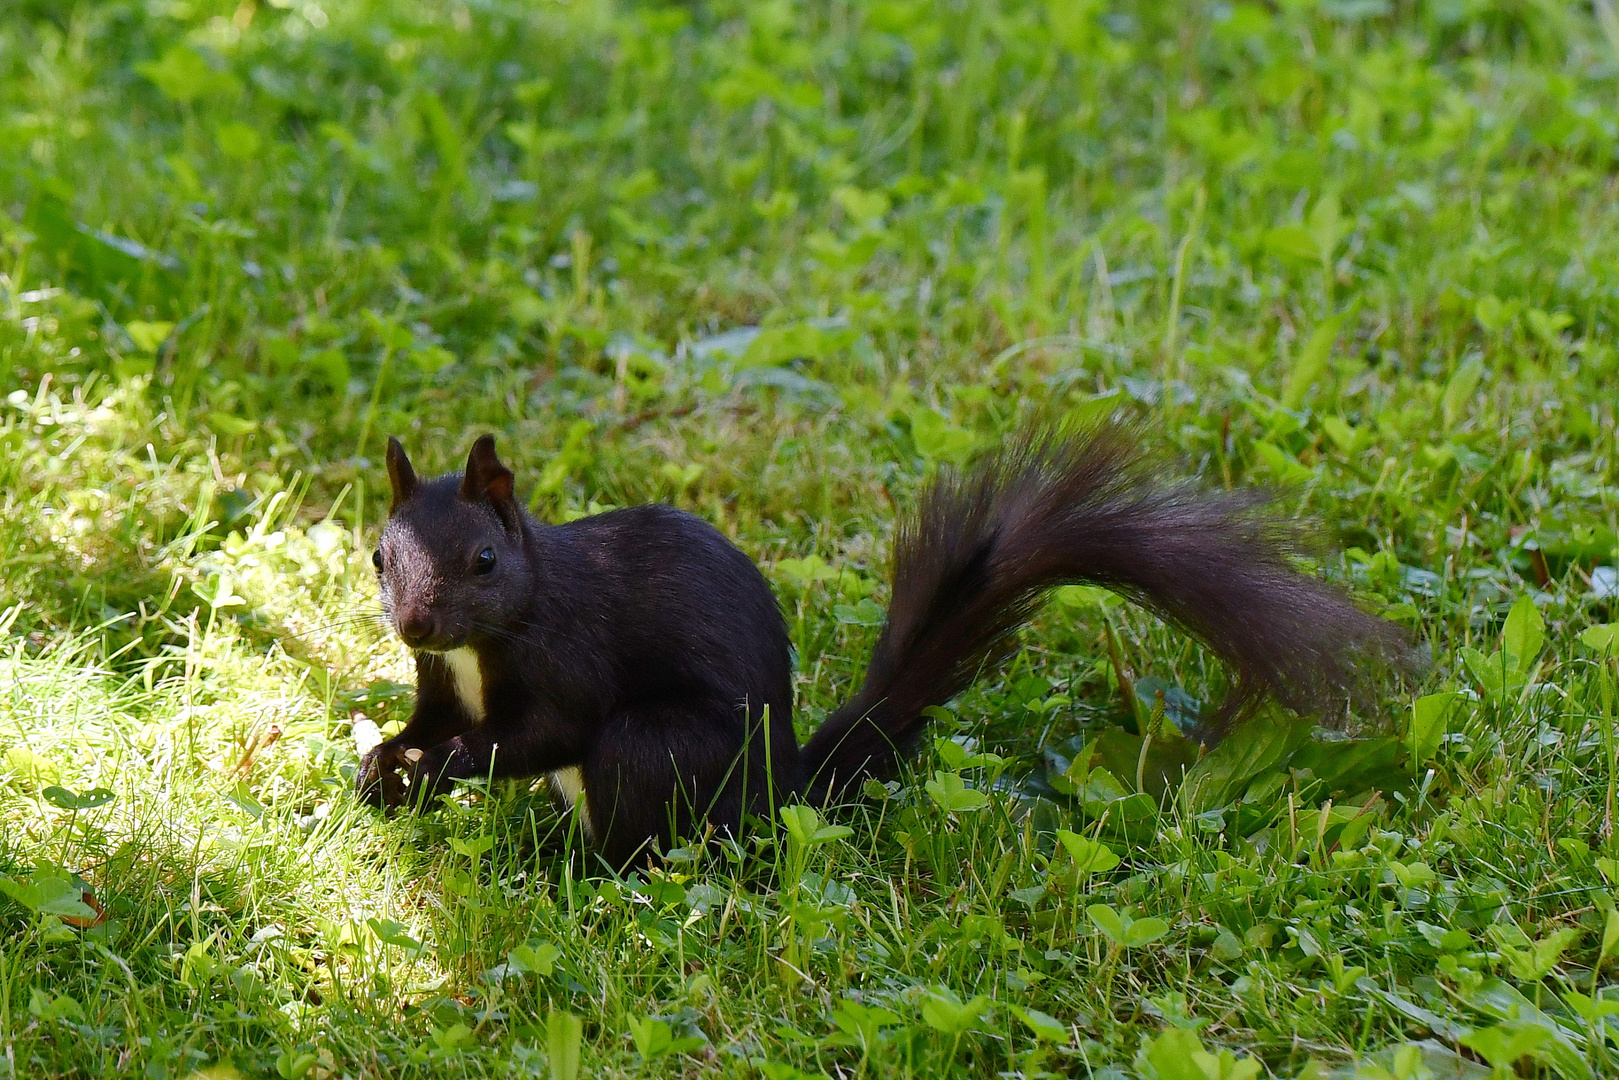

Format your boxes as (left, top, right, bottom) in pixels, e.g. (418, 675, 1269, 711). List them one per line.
(356, 423, 1410, 866)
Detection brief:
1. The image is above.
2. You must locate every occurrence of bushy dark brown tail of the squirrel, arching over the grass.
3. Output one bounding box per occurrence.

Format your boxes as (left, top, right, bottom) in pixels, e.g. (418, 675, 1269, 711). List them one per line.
(805, 423, 1410, 800)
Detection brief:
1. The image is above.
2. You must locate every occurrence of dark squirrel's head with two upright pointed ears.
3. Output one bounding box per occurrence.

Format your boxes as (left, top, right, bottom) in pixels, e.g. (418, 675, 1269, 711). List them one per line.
(371, 436, 534, 653)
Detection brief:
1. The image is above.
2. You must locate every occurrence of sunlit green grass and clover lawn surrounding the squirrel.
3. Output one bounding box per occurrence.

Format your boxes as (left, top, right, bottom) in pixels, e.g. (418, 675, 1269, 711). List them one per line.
(0, 0, 1619, 1080)
